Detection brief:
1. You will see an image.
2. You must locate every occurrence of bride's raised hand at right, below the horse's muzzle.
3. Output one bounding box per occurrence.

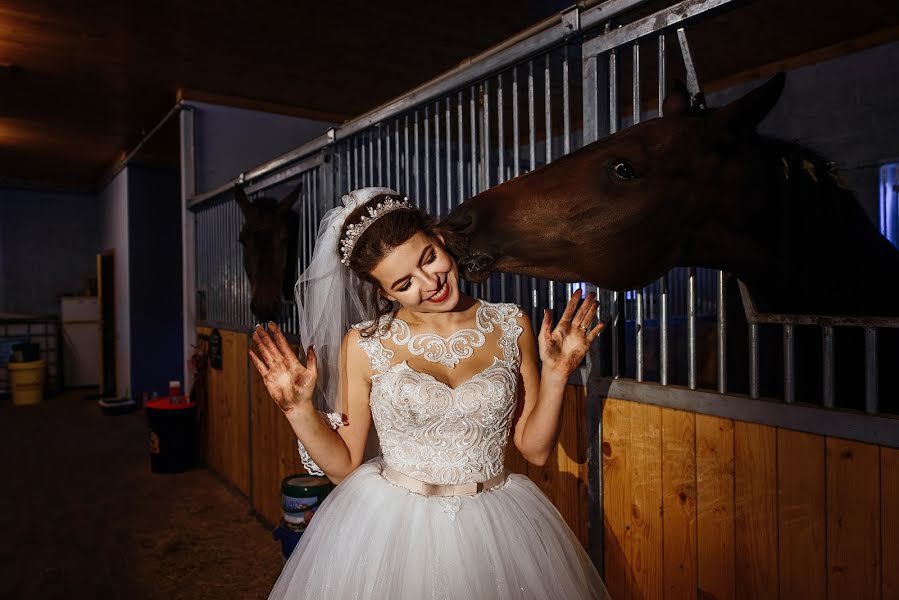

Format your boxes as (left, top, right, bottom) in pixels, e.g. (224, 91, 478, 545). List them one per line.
(537, 289, 605, 377)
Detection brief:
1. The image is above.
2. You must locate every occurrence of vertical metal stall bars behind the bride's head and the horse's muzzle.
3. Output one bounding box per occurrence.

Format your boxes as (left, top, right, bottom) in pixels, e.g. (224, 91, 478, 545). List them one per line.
(335, 43, 592, 322)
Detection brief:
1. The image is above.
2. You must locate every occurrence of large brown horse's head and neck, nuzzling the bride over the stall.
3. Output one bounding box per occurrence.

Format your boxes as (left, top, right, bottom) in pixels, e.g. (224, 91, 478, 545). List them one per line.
(442, 73, 899, 313)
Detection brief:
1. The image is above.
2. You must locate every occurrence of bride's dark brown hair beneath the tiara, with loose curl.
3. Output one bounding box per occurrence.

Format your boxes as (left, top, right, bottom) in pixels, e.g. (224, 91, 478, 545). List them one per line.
(337, 194, 437, 337)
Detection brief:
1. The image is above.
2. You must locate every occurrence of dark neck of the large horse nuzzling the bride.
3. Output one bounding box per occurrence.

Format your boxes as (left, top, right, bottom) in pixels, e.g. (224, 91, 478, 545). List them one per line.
(691, 145, 899, 314)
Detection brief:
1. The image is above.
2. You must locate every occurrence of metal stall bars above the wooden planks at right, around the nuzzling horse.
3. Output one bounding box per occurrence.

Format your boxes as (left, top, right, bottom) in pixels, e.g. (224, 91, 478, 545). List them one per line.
(582, 0, 896, 436)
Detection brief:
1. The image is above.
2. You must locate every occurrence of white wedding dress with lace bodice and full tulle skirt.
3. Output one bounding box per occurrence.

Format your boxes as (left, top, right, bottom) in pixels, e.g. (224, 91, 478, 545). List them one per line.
(269, 301, 608, 600)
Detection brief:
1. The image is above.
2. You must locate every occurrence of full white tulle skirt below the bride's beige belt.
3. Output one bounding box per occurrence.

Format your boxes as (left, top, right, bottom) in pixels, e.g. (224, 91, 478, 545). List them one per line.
(269, 456, 608, 600)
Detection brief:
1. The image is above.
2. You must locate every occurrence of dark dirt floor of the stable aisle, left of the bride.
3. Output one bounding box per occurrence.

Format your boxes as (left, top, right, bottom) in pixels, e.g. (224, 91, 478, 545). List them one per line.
(0, 392, 283, 600)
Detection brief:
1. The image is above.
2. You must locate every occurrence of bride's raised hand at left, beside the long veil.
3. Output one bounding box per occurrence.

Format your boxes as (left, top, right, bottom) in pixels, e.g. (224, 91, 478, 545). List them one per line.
(250, 322, 318, 415)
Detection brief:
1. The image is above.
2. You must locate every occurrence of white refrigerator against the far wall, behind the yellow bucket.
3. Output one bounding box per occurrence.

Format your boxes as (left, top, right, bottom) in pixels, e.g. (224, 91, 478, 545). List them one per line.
(59, 296, 100, 388)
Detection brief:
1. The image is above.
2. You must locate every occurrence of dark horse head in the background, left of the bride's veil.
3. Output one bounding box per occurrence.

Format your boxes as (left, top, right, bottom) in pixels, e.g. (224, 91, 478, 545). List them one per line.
(234, 186, 300, 322)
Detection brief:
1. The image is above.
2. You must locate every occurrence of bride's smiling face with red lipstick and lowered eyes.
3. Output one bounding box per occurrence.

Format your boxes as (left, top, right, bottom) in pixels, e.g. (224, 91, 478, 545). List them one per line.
(371, 232, 460, 312)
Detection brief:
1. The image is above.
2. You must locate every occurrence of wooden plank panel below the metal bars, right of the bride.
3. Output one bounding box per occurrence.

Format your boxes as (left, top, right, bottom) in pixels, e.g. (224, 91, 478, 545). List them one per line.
(602, 399, 899, 600)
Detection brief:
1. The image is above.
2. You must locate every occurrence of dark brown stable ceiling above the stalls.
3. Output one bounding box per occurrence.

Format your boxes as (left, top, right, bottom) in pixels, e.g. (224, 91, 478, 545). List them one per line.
(0, 0, 899, 188)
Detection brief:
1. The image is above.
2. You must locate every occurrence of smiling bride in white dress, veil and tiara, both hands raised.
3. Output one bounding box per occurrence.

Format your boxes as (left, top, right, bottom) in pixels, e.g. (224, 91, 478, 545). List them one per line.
(250, 188, 608, 600)
